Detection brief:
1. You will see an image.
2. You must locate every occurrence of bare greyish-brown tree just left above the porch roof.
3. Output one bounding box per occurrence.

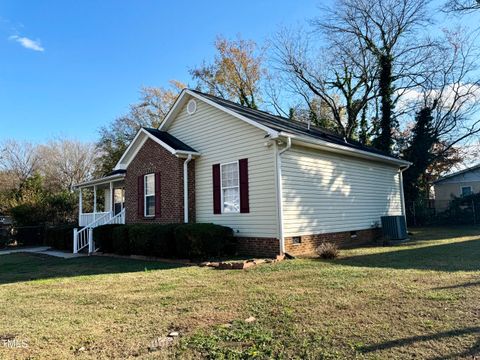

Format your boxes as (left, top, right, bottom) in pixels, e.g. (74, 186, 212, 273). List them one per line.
(39, 138, 98, 191)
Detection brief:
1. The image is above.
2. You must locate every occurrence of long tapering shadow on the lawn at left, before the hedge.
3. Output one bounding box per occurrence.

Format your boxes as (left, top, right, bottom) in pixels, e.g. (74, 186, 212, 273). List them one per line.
(0, 253, 184, 285)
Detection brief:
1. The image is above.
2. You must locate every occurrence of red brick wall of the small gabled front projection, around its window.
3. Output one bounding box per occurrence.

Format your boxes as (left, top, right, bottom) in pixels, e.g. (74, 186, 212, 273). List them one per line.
(125, 139, 195, 224)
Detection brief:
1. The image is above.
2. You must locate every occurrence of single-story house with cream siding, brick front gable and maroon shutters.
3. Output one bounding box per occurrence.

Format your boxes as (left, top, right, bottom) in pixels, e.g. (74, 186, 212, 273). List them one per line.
(76, 89, 409, 256)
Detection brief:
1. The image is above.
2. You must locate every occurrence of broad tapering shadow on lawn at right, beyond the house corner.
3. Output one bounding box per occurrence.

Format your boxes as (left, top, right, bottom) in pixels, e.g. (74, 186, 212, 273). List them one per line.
(336, 240, 480, 271)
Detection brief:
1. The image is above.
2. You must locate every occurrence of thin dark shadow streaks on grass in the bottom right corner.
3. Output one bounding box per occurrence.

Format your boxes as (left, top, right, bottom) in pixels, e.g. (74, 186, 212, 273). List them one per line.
(361, 326, 480, 359)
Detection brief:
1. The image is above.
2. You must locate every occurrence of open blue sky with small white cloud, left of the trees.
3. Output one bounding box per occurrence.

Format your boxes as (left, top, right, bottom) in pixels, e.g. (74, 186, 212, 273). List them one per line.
(0, 0, 319, 142)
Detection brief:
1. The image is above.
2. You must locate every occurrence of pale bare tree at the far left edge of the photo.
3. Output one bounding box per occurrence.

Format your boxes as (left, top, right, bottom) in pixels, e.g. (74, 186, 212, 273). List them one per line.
(0, 140, 40, 183)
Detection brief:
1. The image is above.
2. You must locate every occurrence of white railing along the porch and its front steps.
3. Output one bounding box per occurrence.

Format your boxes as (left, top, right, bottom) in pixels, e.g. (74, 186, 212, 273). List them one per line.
(73, 209, 125, 254)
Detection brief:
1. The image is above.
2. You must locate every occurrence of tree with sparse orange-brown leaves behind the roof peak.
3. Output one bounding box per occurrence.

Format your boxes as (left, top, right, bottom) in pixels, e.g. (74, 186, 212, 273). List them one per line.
(190, 37, 266, 108)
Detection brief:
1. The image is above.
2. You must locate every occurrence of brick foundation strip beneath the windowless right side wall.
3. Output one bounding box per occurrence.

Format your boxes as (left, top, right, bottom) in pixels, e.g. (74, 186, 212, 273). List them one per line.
(285, 229, 382, 255)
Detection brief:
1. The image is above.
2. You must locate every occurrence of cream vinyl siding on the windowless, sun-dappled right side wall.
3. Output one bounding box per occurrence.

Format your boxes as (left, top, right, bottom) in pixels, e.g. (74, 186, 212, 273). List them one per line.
(282, 146, 402, 236)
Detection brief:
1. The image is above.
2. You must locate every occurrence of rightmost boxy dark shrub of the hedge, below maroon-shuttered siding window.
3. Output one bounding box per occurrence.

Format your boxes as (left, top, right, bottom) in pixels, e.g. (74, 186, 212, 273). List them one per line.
(175, 224, 233, 259)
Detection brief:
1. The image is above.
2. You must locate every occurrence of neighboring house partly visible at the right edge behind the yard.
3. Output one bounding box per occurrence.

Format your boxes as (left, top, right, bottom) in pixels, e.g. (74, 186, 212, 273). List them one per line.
(433, 164, 480, 211)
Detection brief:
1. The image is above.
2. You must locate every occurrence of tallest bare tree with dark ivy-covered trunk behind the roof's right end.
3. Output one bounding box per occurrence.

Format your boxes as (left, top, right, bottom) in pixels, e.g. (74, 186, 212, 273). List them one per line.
(314, 0, 430, 152)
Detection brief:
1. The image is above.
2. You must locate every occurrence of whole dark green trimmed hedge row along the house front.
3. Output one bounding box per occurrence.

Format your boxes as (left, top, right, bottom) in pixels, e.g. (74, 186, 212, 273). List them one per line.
(93, 224, 235, 259)
